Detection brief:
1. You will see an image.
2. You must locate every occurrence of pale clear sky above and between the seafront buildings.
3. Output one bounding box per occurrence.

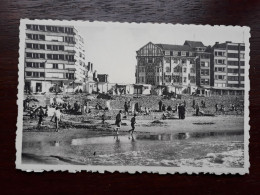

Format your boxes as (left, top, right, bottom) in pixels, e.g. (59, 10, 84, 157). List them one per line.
(75, 22, 249, 83)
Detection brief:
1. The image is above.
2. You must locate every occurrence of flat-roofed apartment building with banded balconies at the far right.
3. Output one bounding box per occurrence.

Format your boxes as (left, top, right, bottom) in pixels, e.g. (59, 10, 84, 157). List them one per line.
(211, 41, 245, 95)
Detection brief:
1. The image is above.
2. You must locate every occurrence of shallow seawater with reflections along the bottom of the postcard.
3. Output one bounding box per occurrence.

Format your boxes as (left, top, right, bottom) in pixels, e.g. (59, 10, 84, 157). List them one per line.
(23, 131, 243, 166)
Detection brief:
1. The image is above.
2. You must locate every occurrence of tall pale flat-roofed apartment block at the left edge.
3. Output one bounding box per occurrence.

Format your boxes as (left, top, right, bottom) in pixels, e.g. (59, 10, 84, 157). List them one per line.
(24, 24, 87, 92)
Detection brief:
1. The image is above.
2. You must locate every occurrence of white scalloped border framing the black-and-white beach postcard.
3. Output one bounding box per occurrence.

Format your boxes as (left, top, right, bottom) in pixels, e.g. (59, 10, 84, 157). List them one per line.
(15, 19, 251, 175)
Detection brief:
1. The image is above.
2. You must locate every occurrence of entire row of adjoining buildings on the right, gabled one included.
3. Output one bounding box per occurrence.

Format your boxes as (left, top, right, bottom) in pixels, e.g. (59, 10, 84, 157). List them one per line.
(135, 41, 245, 96)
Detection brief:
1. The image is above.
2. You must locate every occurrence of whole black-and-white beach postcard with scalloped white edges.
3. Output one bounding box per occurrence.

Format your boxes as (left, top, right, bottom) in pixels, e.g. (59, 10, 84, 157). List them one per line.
(16, 19, 250, 175)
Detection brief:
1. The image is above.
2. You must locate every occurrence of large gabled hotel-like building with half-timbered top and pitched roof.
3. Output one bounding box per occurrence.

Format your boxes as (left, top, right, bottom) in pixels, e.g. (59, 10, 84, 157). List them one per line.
(136, 42, 196, 93)
